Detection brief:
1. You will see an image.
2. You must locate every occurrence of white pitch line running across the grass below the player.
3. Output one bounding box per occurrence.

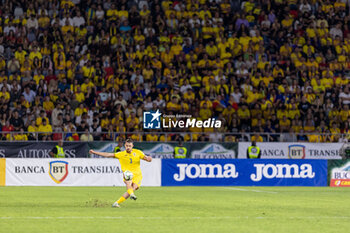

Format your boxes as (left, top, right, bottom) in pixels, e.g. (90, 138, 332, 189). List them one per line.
(0, 216, 350, 220)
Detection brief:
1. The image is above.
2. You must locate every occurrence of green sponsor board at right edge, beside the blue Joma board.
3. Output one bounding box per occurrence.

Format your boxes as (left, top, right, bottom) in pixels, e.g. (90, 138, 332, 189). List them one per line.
(328, 159, 350, 184)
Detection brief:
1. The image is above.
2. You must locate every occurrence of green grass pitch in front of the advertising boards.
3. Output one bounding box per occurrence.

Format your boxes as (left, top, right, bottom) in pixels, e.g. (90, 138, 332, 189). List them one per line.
(0, 187, 350, 233)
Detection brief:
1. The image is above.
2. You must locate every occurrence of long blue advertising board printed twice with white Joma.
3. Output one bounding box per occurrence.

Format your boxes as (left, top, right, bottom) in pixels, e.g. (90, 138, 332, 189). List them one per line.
(162, 159, 327, 186)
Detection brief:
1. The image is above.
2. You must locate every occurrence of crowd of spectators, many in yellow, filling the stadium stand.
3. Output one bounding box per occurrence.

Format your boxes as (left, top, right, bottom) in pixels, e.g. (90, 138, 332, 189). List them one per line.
(0, 0, 350, 142)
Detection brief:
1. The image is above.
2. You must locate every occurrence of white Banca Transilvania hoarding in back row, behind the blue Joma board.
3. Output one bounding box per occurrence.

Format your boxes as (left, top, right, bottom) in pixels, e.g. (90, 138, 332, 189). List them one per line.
(238, 142, 343, 159)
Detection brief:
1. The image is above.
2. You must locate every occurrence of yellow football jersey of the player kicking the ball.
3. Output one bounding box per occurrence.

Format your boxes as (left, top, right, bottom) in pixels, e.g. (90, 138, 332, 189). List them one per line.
(114, 149, 145, 177)
